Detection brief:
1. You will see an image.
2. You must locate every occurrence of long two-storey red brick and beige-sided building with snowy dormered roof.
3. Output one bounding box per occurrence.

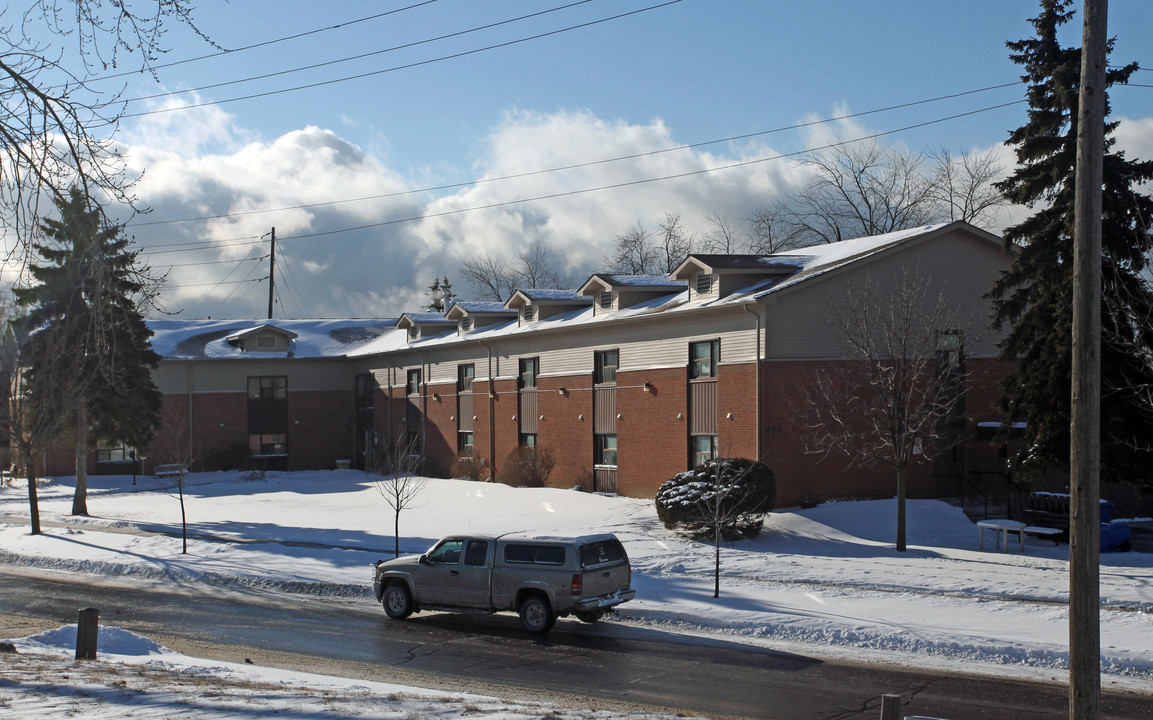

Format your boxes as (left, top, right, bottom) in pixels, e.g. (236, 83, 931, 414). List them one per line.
(44, 222, 1009, 507)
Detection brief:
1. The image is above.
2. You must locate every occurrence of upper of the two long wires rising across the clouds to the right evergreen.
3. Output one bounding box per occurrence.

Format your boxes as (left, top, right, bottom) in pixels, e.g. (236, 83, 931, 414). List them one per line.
(129, 81, 1022, 227)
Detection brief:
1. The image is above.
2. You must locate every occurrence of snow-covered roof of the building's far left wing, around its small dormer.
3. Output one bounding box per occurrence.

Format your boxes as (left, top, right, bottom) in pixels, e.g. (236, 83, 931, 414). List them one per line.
(148, 318, 395, 359)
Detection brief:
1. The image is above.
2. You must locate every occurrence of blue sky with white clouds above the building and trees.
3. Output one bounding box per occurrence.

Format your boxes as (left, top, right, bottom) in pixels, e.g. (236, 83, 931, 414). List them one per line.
(36, 0, 1153, 317)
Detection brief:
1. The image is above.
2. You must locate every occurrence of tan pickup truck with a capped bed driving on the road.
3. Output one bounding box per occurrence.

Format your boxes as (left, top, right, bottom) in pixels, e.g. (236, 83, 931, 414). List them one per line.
(372, 534, 636, 633)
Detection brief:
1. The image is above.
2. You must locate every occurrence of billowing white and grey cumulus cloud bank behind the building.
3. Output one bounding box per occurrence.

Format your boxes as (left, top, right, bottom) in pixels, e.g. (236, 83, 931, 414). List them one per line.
(92, 101, 1153, 317)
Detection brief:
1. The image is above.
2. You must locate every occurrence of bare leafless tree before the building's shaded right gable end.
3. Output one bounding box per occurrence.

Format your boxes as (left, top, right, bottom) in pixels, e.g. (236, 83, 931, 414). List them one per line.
(804, 269, 975, 552)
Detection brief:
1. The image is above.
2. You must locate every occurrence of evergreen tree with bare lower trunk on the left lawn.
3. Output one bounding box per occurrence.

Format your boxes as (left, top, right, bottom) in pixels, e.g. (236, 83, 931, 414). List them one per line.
(14, 188, 161, 515)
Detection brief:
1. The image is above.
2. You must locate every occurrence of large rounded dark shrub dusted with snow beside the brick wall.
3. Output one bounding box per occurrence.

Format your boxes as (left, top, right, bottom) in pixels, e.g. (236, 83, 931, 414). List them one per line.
(656, 458, 777, 540)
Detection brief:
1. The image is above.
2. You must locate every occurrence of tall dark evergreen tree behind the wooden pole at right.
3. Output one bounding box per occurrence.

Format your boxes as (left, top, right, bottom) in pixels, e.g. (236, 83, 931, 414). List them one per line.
(989, 0, 1153, 488)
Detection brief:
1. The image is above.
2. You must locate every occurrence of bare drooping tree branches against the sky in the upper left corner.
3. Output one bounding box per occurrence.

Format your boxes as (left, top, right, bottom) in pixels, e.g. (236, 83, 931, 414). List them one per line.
(0, 0, 203, 254)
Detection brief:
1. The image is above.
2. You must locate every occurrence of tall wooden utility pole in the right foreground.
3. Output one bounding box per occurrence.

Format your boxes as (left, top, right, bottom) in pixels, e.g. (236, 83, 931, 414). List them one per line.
(1069, 0, 1109, 720)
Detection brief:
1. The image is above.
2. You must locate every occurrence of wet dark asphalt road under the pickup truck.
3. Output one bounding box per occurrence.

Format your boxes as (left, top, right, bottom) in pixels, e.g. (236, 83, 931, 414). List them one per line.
(0, 565, 1153, 720)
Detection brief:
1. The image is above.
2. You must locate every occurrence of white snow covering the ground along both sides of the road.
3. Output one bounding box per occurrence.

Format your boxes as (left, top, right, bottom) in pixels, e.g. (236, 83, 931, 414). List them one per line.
(0, 471, 1153, 718)
